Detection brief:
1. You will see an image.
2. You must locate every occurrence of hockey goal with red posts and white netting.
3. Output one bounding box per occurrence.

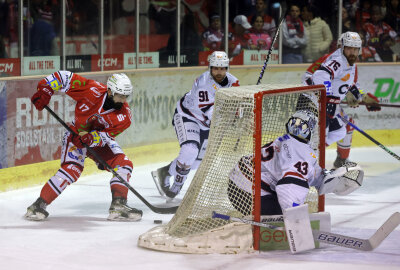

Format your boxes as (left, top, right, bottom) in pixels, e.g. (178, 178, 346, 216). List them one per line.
(138, 85, 325, 253)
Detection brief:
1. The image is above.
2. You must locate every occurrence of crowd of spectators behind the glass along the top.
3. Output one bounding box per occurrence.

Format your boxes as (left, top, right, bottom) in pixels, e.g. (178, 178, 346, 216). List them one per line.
(0, 0, 400, 63)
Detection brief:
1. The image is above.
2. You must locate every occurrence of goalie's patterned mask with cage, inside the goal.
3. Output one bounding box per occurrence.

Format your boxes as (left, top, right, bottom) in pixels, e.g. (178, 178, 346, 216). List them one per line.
(286, 110, 317, 143)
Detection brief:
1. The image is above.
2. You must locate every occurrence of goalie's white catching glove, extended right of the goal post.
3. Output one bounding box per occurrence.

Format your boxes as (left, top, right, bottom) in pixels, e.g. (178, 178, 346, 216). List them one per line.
(319, 162, 364, 196)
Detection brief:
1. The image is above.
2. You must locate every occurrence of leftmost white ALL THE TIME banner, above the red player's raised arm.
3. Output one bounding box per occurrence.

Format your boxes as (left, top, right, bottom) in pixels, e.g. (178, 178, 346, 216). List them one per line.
(23, 56, 60, 75)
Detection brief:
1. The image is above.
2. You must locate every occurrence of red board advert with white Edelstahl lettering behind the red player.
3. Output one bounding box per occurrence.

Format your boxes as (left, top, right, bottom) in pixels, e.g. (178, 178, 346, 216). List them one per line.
(0, 74, 108, 167)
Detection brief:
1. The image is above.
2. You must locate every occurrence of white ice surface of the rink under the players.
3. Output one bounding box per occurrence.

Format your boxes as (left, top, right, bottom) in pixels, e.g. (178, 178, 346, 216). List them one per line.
(0, 147, 400, 270)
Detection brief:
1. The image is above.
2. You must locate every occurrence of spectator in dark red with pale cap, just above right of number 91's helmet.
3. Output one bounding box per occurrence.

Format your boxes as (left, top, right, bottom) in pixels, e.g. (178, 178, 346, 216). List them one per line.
(229, 15, 251, 57)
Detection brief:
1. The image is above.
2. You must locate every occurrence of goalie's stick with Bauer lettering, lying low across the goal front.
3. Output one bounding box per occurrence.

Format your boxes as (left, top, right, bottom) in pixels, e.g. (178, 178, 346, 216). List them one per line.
(212, 212, 400, 251)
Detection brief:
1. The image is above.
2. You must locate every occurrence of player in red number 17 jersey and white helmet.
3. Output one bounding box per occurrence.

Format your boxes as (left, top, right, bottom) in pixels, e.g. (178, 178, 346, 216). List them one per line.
(25, 71, 142, 221)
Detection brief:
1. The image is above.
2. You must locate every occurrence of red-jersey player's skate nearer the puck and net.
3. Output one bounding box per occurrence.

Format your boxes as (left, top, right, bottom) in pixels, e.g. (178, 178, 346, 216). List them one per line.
(107, 197, 143, 221)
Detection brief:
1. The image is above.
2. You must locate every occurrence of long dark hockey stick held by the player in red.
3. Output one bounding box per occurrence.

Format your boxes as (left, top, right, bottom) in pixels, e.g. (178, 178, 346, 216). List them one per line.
(44, 106, 178, 214)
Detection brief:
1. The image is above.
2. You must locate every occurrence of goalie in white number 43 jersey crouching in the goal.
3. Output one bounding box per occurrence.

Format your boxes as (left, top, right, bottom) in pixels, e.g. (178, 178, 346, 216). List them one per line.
(228, 110, 364, 215)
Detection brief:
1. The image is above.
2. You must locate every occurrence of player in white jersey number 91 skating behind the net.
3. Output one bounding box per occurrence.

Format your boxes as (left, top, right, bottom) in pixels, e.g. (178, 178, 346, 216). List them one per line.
(152, 51, 239, 198)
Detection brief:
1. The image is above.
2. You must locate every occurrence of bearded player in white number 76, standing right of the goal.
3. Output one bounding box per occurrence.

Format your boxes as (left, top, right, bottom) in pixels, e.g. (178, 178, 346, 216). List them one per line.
(303, 32, 380, 168)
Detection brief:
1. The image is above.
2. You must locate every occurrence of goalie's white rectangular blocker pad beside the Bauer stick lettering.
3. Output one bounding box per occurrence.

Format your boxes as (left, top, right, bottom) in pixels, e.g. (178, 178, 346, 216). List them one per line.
(283, 204, 315, 253)
